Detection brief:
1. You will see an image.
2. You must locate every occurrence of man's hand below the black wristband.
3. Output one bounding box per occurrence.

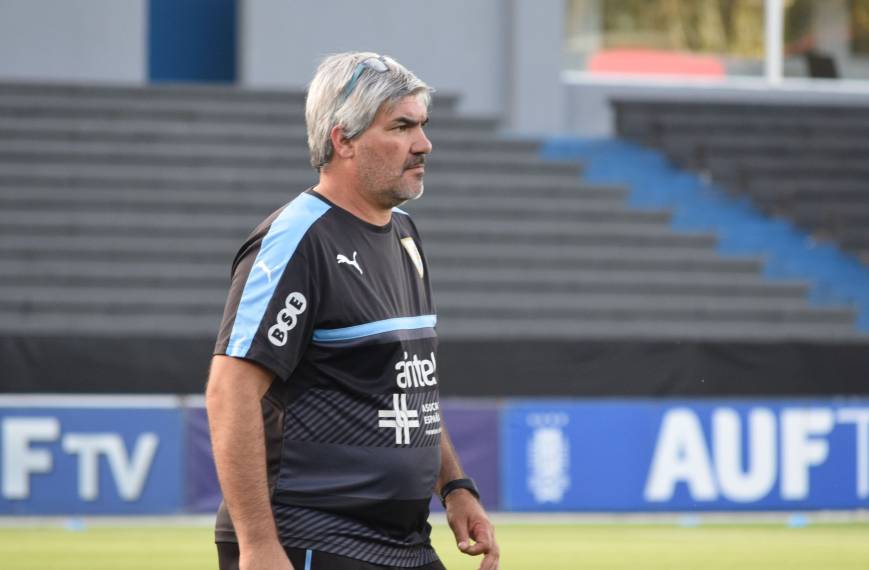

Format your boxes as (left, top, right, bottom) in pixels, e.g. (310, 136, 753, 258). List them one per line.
(446, 489, 501, 570)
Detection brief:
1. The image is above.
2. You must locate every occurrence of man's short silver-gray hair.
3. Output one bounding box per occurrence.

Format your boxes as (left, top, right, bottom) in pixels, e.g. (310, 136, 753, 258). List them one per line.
(305, 52, 434, 170)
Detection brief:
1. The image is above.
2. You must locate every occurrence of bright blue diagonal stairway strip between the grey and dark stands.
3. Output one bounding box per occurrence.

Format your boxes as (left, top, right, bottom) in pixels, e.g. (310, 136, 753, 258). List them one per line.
(545, 139, 869, 332)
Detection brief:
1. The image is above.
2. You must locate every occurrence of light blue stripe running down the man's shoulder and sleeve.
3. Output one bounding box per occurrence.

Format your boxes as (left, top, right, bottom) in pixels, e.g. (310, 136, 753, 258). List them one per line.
(226, 193, 330, 356)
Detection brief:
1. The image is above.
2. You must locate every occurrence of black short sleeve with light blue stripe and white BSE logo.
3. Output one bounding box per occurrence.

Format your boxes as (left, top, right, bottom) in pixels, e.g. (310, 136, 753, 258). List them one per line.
(214, 194, 327, 380)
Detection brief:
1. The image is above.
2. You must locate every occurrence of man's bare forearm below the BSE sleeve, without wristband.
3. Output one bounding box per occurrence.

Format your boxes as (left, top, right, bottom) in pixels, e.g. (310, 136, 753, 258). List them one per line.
(206, 357, 277, 547)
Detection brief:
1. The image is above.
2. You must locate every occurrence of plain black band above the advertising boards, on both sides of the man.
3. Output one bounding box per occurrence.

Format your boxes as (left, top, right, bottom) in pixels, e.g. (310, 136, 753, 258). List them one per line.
(0, 336, 869, 398)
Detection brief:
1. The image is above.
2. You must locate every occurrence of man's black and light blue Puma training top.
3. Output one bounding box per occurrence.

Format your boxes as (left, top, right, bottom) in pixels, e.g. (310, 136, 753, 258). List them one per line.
(215, 190, 441, 567)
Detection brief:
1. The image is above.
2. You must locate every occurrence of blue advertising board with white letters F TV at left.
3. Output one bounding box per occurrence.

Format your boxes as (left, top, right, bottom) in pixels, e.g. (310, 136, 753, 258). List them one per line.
(0, 406, 184, 515)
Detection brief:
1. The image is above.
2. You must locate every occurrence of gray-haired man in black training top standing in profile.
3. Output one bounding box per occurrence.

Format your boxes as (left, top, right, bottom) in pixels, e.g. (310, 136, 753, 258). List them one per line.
(206, 53, 499, 570)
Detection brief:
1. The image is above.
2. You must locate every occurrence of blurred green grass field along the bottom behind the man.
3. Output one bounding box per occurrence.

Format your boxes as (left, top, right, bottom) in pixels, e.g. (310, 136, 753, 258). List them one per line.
(0, 523, 869, 570)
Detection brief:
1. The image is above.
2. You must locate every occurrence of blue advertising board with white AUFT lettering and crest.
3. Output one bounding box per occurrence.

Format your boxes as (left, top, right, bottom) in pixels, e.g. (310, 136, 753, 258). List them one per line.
(501, 399, 869, 511)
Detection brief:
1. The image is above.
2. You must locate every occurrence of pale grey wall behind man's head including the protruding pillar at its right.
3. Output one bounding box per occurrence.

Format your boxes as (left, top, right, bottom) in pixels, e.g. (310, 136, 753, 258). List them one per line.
(239, 0, 565, 132)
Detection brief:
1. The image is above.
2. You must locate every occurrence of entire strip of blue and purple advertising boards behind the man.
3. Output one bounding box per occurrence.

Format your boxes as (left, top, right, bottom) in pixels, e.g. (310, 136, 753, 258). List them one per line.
(0, 396, 869, 515)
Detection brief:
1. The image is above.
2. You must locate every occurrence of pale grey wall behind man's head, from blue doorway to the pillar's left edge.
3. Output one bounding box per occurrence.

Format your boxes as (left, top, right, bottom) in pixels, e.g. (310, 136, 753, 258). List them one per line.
(239, 0, 504, 114)
